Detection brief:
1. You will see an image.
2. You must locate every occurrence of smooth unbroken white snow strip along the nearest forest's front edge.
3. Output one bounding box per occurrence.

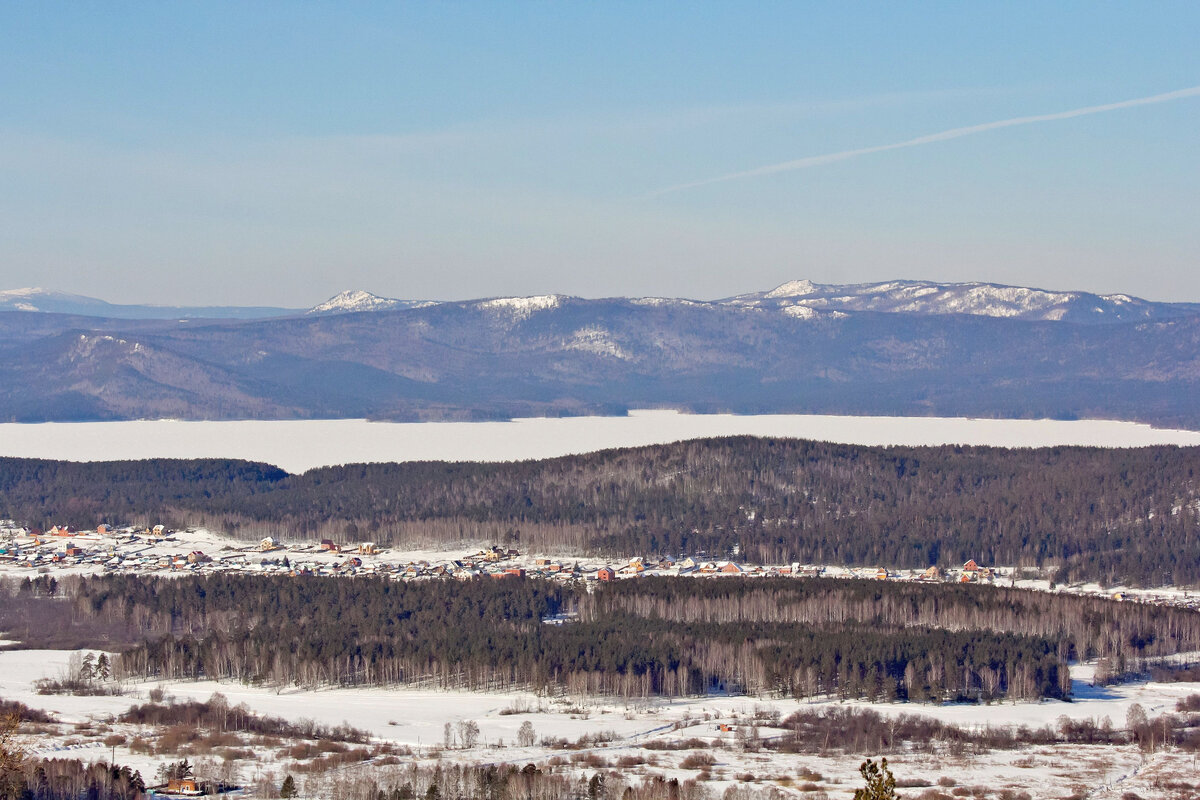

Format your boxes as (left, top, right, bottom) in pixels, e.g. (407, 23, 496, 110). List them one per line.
(0, 650, 1200, 746)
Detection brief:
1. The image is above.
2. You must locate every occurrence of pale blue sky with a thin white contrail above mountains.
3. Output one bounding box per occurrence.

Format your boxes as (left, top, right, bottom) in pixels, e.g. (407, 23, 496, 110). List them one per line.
(0, 0, 1200, 306)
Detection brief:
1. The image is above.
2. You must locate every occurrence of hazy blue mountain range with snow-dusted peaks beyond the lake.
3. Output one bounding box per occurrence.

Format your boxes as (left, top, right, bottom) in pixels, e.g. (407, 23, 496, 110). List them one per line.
(0, 281, 1200, 428)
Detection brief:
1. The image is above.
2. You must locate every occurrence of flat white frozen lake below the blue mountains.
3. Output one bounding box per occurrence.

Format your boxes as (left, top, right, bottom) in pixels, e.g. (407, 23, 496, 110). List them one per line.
(0, 410, 1200, 473)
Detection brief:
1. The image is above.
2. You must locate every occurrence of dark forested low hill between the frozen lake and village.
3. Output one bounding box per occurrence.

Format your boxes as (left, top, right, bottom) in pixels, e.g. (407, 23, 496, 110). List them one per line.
(0, 438, 1200, 585)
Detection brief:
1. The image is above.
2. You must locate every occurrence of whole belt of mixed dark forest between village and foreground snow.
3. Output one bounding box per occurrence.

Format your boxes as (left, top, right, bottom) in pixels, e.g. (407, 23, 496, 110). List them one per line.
(11, 575, 1200, 700)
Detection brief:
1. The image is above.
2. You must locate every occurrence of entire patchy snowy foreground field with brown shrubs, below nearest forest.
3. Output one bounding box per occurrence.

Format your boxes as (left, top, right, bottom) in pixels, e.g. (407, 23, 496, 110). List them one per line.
(0, 651, 1200, 800)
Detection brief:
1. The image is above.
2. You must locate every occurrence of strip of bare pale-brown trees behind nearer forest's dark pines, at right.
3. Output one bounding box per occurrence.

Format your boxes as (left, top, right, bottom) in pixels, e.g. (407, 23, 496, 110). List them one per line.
(580, 577, 1200, 674)
